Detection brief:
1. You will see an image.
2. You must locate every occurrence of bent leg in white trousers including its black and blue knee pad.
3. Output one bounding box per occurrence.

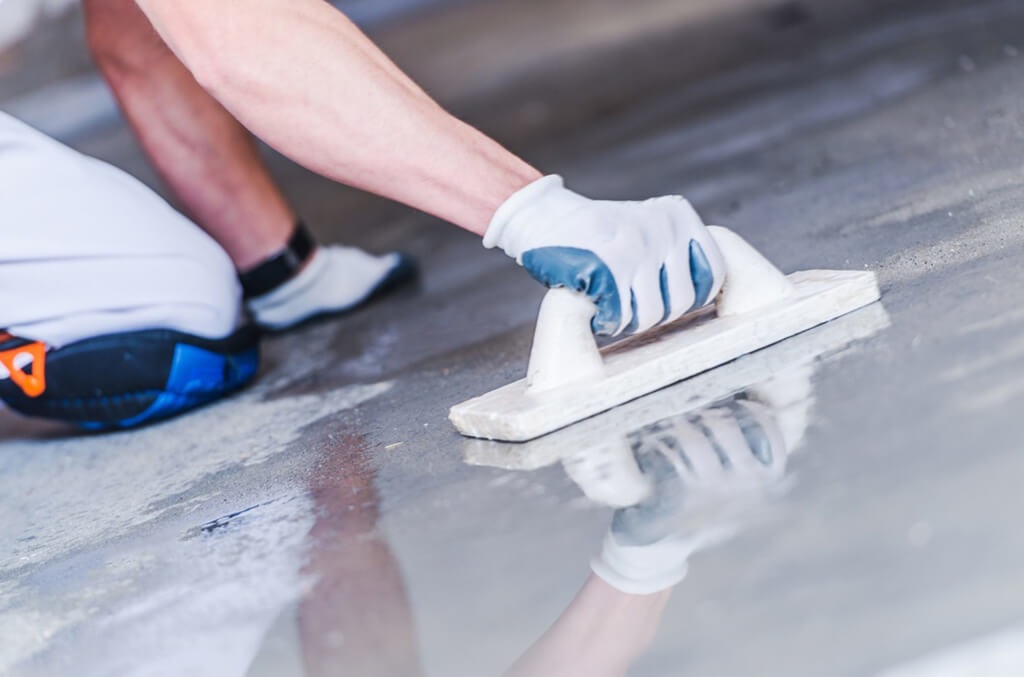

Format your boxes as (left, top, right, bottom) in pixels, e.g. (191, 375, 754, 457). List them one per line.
(0, 114, 258, 428)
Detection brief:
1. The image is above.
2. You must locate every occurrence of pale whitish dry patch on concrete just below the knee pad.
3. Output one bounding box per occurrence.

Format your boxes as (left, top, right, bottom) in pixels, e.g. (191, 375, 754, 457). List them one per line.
(0, 382, 390, 576)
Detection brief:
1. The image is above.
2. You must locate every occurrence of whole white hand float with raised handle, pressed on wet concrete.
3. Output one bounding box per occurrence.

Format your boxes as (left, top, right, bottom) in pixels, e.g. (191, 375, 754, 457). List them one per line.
(449, 226, 879, 441)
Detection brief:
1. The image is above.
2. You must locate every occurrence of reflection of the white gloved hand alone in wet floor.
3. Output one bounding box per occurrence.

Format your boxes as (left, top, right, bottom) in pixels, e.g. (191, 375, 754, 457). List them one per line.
(592, 399, 786, 594)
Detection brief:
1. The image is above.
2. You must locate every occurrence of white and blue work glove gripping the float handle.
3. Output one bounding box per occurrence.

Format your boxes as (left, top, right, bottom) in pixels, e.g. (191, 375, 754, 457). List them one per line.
(483, 175, 725, 335)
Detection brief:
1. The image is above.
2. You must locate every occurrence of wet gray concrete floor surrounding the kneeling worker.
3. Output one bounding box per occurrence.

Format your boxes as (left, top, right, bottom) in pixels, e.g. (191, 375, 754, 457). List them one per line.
(0, 0, 1024, 676)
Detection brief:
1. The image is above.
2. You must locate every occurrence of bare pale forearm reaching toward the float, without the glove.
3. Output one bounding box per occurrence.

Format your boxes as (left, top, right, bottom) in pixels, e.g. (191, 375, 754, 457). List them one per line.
(137, 0, 540, 234)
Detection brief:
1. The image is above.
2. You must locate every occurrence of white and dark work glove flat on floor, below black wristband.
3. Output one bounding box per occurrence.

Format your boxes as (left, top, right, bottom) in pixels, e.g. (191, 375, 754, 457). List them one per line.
(246, 245, 416, 330)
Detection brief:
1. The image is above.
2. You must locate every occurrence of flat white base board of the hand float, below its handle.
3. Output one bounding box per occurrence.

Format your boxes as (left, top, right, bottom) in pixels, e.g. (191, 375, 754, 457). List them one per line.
(449, 270, 880, 441)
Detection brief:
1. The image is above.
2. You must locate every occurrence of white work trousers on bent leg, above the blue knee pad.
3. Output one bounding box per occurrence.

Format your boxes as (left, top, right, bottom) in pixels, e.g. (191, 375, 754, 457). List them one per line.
(0, 113, 241, 347)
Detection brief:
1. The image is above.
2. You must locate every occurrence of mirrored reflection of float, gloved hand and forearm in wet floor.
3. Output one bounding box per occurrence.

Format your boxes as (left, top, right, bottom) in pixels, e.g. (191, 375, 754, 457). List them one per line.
(452, 304, 889, 675)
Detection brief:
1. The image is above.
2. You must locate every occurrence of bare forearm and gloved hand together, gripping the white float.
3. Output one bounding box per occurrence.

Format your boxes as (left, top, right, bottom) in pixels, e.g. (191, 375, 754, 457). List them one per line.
(135, 0, 725, 334)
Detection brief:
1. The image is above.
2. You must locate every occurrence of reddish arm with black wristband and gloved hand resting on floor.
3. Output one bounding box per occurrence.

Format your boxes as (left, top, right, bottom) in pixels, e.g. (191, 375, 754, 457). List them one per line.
(83, 0, 415, 330)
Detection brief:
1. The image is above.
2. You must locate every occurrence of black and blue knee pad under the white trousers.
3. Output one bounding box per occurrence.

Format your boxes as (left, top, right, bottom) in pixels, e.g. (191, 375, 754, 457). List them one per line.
(0, 327, 259, 430)
